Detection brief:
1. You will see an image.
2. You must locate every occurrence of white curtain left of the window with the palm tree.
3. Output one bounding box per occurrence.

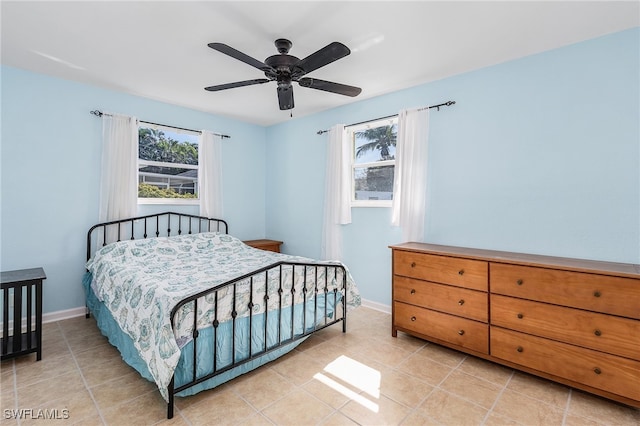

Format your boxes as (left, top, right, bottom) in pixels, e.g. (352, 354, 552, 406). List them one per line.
(321, 124, 351, 260)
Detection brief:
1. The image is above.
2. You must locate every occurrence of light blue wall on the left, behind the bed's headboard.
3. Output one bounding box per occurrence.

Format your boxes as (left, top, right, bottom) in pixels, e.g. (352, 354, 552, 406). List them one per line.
(0, 66, 266, 313)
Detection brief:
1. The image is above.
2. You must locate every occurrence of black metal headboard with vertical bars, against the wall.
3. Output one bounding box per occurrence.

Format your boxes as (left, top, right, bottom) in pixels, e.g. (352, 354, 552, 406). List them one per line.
(87, 212, 229, 260)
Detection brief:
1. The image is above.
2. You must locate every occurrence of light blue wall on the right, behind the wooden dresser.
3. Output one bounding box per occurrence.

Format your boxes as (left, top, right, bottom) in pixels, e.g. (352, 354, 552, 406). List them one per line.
(266, 28, 640, 305)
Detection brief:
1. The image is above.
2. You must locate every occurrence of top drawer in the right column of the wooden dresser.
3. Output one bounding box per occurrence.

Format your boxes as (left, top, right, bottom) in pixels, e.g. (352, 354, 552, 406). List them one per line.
(491, 263, 640, 319)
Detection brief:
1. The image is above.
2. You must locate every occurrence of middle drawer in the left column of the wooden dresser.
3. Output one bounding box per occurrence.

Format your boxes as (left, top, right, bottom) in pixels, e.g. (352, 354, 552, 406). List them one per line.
(393, 275, 489, 322)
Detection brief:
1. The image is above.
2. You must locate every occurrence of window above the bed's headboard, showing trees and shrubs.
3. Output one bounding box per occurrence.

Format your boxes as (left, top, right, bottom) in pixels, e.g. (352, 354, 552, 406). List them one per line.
(138, 123, 199, 204)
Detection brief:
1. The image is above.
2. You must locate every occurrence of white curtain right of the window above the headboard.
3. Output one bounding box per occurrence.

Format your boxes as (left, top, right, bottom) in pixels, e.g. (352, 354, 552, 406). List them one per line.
(198, 130, 223, 218)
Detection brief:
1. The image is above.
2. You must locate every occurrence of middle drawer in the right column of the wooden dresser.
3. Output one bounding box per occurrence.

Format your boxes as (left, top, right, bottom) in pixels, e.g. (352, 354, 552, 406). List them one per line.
(491, 295, 640, 361)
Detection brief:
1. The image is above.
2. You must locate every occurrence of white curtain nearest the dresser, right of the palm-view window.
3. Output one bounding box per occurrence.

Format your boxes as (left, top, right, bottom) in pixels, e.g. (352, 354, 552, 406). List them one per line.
(391, 108, 429, 242)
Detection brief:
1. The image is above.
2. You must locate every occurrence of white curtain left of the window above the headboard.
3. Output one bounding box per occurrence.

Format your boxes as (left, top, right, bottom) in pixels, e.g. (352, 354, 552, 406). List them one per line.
(99, 113, 138, 236)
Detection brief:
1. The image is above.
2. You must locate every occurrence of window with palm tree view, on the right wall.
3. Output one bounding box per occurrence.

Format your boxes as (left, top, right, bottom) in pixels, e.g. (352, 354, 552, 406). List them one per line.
(347, 116, 398, 207)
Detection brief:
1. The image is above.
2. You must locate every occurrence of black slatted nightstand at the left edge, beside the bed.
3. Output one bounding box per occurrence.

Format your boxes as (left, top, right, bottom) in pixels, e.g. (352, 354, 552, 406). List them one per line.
(0, 268, 47, 361)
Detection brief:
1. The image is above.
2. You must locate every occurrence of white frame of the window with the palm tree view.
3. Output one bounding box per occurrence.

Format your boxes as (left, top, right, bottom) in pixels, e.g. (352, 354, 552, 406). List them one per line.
(345, 115, 398, 208)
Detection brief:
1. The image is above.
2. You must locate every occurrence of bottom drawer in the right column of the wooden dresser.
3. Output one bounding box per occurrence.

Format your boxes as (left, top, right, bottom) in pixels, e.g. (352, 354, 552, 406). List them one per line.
(491, 327, 640, 401)
